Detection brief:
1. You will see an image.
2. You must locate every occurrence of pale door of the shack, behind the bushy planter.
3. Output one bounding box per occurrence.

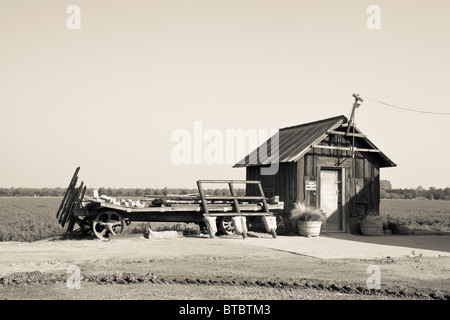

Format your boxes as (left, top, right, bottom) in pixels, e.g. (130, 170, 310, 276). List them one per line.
(319, 169, 342, 231)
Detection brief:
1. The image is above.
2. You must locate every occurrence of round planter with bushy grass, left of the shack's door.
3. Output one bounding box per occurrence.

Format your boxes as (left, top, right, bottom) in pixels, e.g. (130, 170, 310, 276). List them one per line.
(289, 202, 326, 238)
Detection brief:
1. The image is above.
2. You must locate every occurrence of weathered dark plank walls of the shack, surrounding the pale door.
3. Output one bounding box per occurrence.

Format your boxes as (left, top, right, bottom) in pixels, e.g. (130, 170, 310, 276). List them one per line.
(247, 135, 380, 233)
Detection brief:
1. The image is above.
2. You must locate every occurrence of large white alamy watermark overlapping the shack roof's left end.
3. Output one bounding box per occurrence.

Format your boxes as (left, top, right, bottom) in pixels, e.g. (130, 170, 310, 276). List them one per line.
(171, 121, 279, 175)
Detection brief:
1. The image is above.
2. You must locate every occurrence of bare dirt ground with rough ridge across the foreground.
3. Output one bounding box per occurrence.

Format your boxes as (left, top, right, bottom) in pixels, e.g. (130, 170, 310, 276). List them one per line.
(0, 230, 450, 300)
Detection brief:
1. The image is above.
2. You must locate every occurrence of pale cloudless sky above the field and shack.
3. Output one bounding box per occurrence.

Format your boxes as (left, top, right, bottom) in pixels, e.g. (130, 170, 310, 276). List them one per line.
(0, 0, 450, 188)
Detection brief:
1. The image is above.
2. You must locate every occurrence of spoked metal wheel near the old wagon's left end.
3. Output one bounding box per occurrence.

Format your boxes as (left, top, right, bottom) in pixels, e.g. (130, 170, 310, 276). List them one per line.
(92, 211, 125, 240)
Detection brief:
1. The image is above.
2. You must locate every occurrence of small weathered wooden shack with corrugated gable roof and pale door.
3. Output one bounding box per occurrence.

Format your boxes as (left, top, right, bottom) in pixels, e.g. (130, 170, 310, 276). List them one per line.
(234, 116, 396, 233)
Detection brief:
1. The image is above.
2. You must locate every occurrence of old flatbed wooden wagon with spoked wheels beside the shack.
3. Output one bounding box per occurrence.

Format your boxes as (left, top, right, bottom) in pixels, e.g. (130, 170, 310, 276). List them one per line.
(56, 167, 283, 240)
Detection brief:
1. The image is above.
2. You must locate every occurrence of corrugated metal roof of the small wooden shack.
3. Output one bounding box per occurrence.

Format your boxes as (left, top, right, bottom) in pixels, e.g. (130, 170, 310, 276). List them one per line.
(233, 116, 395, 168)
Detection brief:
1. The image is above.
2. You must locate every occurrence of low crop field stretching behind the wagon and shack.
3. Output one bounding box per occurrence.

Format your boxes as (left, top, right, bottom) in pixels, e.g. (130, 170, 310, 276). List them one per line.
(0, 198, 450, 241)
